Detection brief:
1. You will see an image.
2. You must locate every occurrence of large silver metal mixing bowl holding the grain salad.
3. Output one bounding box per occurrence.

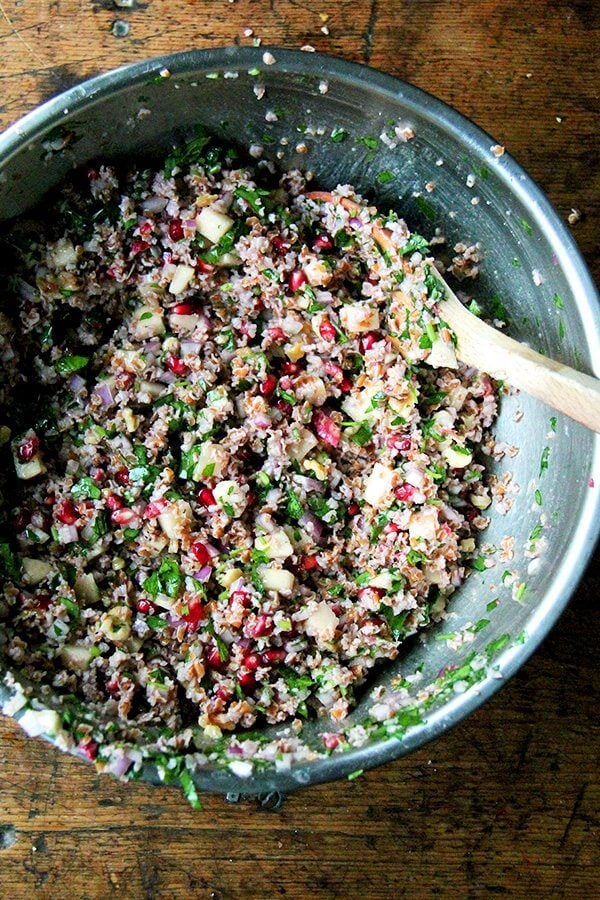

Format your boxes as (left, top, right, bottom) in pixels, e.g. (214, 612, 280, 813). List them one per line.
(0, 47, 600, 794)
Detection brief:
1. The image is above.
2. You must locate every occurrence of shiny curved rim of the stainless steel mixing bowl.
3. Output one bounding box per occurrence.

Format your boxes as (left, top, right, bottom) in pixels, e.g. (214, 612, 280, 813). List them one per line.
(0, 46, 600, 794)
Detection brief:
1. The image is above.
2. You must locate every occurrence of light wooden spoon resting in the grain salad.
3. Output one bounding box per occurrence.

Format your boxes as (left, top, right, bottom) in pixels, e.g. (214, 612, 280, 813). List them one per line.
(306, 191, 600, 433)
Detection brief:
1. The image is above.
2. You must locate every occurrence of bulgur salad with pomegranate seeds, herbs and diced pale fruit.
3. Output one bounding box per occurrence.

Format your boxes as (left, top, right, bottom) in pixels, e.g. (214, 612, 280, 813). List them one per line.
(0, 134, 497, 758)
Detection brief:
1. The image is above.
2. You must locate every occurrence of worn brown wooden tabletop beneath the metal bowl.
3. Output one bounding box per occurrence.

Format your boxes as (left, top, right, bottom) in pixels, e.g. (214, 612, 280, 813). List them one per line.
(0, 0, 600, 900)
